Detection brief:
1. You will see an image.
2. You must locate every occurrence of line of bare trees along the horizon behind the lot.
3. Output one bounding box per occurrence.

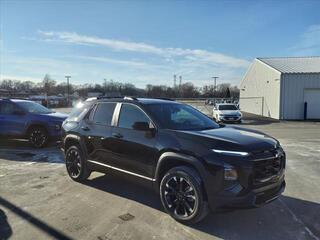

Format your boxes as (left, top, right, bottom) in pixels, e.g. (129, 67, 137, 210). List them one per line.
(0, 74, 239, 98)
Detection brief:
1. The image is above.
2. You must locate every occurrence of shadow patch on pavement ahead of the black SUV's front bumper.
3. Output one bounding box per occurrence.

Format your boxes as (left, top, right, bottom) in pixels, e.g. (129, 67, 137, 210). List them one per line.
(193, 196, 320, 240)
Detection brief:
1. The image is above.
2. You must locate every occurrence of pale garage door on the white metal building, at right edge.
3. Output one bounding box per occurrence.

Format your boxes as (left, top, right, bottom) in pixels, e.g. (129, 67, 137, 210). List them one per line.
(304, 89, 320, 119)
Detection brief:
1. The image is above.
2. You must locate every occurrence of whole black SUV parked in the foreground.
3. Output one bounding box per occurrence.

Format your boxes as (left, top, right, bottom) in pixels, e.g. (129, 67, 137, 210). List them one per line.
(63, 97, 286, 223)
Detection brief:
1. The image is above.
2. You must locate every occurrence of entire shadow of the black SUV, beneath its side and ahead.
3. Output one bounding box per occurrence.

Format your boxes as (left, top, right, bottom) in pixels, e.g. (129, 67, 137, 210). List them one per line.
(84, 174, 320, 239)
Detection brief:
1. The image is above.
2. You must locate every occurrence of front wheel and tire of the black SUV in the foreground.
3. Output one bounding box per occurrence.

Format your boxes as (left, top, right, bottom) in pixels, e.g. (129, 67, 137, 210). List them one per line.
(160, 166, 208, 224)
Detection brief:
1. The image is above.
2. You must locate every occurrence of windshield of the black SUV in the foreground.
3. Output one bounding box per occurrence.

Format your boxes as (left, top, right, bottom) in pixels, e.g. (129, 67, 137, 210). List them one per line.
(146, 103, 219, 130)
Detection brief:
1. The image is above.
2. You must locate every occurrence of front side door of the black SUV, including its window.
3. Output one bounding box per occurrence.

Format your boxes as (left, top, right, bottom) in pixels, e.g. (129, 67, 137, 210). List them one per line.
(108, 103, 157, 177)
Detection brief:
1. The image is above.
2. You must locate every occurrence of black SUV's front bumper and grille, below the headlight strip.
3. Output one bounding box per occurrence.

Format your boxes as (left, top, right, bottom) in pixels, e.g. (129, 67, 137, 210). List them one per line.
(204, 151, 286, 210)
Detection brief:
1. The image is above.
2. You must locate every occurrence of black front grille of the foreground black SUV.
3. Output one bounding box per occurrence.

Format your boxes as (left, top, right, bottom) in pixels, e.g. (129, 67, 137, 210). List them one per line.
(253, 154, 285, 184)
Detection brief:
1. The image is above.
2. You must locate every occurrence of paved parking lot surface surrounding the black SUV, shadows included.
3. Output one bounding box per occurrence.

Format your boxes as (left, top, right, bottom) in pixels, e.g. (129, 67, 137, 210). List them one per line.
(0, 106, 320, 240)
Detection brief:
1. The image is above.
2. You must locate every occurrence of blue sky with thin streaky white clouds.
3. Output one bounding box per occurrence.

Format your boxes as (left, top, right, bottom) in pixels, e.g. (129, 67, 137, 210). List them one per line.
(0, 0, 320, 87)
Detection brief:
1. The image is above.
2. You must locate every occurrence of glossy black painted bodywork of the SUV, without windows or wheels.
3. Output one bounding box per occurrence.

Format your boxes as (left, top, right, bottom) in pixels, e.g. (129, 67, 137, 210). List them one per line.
(63, 100, 285, 210)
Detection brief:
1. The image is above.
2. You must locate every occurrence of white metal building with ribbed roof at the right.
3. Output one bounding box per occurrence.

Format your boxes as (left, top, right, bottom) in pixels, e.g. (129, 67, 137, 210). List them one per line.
(240, 57, 320, 120)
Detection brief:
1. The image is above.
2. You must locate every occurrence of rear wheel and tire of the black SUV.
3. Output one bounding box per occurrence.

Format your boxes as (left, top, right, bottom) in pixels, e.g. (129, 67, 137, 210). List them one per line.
(65, 145, 91, 182)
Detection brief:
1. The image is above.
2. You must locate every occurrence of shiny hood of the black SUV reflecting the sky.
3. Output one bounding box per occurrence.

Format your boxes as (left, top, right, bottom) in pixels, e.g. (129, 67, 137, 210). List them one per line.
(181, 127, 278, 152)
